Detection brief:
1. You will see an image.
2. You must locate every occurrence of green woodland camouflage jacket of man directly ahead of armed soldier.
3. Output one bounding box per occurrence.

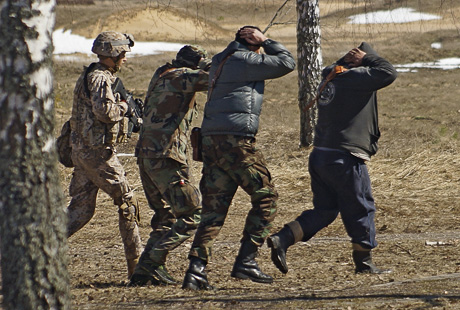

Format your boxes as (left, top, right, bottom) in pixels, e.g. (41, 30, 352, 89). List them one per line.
(136, 63, 209, 164)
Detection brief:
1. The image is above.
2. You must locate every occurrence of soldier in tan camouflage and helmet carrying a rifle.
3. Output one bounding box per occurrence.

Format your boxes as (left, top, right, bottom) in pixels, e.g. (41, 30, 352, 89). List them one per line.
(67, 31, 142, 278)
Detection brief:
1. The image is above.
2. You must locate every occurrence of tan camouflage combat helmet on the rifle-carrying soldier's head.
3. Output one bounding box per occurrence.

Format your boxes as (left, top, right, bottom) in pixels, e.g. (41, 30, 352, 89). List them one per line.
(91, 31, 134, 57)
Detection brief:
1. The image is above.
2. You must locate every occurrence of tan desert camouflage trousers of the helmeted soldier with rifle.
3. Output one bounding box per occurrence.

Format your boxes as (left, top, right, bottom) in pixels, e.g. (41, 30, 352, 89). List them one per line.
(67, 149, 142, 260)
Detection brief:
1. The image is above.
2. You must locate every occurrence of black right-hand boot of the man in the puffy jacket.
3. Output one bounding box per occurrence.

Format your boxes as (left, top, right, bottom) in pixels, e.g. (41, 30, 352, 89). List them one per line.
(231, 240, 273, 283)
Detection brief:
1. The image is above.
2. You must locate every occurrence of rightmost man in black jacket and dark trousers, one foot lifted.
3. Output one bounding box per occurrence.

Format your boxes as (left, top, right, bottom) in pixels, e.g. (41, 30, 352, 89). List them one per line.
(267, 42, 397, 273)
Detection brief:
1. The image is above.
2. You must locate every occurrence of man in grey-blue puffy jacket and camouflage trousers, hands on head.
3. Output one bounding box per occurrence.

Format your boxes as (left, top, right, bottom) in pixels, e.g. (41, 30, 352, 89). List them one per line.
(182, 26, 295, 290)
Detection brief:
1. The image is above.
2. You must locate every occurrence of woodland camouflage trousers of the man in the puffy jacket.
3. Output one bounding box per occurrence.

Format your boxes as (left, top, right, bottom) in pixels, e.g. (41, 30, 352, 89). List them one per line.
(190, 135, 278, 261)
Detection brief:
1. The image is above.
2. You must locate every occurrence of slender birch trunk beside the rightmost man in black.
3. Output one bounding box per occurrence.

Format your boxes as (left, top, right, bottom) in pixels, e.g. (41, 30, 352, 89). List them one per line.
(296, 0, 322, 146)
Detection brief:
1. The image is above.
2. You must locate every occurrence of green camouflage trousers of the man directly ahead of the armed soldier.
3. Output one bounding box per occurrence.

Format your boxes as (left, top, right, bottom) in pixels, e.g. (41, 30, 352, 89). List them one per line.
(135, 158, 201, 266)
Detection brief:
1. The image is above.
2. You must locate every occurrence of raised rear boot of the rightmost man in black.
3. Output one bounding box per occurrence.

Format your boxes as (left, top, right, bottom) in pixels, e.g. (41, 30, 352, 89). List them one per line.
(267, 225, 295, 273)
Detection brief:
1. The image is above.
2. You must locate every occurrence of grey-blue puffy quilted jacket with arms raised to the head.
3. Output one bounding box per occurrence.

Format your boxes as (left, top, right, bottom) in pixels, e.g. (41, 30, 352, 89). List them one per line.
(201, 39, 295, 137)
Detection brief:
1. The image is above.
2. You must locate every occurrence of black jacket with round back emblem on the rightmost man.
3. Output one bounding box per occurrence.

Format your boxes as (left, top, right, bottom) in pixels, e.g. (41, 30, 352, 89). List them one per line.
(313, 42, 397, 157)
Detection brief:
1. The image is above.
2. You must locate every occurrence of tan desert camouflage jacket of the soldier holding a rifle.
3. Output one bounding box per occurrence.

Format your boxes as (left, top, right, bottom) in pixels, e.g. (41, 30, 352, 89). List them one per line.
(70, 63, 128, 150)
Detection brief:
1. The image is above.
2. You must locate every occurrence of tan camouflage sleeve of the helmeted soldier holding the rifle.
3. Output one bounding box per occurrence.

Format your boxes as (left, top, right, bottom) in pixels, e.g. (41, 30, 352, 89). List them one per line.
(88, 74, 128, 123)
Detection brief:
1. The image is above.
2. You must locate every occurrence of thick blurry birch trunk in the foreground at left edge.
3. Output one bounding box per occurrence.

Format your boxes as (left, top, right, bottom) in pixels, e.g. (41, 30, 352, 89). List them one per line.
(0, 0, 70, 309)
